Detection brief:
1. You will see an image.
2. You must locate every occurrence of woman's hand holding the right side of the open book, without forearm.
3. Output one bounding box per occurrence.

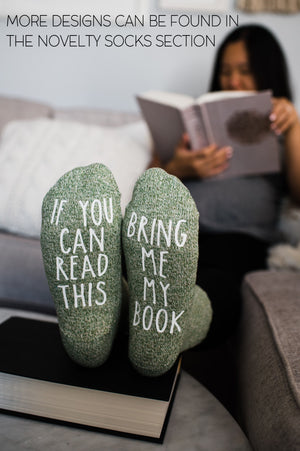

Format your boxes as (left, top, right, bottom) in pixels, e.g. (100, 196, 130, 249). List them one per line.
(270, 97, 299, 135)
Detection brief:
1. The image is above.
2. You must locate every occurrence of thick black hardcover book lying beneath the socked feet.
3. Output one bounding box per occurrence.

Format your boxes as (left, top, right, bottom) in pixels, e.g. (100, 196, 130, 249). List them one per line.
(0, 317, 180, 441)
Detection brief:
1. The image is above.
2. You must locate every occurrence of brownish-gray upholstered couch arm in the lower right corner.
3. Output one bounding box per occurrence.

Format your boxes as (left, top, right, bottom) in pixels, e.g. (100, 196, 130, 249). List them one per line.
(238, 271, 300, 451)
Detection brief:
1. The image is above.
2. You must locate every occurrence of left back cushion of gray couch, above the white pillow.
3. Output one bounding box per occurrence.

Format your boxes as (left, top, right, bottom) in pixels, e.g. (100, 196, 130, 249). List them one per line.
(0, 96, 53, 133)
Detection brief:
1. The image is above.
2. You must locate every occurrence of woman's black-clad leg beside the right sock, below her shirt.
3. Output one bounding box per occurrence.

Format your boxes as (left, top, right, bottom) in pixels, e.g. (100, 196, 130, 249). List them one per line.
(197, 233, 268, 346)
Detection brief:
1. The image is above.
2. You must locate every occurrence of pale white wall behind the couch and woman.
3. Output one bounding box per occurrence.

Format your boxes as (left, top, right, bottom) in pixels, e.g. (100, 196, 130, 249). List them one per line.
(0, 0, 300, 111)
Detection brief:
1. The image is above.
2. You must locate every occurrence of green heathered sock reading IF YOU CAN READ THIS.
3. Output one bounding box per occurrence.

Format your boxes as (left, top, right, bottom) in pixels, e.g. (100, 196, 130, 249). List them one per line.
(41, 164, 122, 367)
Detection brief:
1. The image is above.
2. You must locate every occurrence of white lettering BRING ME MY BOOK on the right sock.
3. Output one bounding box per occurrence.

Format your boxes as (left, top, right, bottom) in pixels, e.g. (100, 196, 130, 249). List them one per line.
(127, 212, 192, 335)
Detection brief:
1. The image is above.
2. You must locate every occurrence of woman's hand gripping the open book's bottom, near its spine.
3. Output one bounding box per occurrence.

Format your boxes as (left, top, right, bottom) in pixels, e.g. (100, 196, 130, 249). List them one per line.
(164, 133, 232, 179)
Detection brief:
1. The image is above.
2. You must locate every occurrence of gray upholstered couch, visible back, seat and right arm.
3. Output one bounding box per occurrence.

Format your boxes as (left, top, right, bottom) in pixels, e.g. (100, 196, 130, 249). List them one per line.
(0, 97, 300, 451)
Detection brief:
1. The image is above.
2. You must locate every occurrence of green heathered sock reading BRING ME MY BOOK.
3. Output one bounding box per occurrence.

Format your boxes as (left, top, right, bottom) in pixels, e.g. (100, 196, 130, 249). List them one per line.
(122, 168, 212, 376)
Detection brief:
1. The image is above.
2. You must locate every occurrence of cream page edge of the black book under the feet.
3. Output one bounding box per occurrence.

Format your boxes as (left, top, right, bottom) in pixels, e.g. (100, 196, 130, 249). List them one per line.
(0, 373, 173, 438)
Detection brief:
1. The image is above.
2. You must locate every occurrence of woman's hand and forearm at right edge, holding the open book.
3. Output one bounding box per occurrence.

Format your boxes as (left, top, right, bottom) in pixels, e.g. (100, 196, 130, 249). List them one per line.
(270, 98, 300, 202)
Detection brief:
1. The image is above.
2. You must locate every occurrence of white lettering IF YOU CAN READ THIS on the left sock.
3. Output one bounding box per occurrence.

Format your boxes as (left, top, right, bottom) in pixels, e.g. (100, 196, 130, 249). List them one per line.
(51, 198, 114, 316)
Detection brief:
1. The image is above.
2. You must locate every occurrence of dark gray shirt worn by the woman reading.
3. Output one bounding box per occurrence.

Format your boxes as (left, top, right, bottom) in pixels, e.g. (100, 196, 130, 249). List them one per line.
(184, 174, 283, 241)
